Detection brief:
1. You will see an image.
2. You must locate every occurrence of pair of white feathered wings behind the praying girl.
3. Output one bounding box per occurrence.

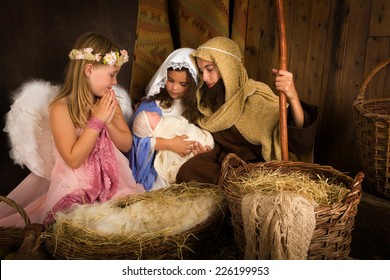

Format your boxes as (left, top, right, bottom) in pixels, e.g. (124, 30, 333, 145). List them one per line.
(4, 80, 132, 180)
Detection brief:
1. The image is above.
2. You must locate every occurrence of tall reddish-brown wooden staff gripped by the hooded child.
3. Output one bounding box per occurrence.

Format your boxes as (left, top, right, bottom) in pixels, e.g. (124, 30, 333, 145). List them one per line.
(276, 0, 288, 161)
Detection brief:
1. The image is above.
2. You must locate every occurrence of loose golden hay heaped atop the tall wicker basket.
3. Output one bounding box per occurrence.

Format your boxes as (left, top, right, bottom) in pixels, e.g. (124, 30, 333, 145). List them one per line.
(228, 168, 350, 207)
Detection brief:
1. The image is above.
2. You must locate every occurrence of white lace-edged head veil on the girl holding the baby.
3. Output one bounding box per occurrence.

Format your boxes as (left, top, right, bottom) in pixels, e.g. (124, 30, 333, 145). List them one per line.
(145, 48, 198, 97)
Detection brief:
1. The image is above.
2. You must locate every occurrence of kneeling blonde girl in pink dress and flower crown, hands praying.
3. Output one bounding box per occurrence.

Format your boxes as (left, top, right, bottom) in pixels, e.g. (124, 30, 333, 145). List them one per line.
(0, 33, 144, 226)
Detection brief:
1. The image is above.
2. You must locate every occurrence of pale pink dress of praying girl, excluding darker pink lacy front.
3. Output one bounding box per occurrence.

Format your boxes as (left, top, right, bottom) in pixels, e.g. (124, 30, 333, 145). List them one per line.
(0, 130, 145, 227)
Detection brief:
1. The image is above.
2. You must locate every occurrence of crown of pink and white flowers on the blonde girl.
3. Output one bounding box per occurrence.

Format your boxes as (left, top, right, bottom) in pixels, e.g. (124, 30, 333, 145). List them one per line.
(69, 48, 129, 66)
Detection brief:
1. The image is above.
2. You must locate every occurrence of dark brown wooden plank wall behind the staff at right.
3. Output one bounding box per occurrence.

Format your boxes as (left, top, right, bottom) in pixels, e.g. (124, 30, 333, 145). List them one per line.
(245, 0, 390, 176)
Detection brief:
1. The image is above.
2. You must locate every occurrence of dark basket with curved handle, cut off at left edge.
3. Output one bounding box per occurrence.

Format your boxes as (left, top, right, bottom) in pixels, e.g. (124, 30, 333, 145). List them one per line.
(0, 196, 30, 248)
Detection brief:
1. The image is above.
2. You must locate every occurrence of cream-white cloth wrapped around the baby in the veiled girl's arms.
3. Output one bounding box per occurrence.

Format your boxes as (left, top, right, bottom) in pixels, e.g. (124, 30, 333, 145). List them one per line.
(133, 111, 214, 187)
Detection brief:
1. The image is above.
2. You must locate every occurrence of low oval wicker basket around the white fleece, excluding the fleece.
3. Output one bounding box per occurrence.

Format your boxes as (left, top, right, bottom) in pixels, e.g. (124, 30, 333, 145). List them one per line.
(45, 184, 227, 260)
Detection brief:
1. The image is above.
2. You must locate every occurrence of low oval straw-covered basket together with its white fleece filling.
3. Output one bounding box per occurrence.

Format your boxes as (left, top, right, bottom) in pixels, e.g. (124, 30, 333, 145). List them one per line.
(47, 183, 225, 259)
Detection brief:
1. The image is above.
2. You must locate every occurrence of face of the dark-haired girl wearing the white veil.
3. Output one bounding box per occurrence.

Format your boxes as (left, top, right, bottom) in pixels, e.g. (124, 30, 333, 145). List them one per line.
(165, 70, 189, 99)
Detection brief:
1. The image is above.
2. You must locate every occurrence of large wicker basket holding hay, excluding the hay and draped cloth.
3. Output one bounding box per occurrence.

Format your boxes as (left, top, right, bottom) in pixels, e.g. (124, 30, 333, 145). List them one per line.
(220, 154, 364, 260)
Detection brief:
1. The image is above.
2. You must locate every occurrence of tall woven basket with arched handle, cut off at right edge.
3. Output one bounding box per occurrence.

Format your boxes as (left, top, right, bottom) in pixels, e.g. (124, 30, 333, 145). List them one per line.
(353, 58, 390, 199)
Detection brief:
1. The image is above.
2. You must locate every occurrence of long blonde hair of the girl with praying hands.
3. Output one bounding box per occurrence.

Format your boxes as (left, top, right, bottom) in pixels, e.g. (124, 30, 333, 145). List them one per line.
(53, 32, 119, 128)
